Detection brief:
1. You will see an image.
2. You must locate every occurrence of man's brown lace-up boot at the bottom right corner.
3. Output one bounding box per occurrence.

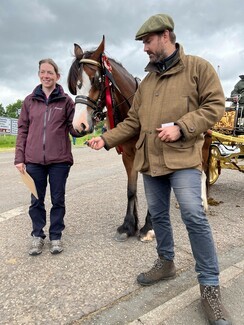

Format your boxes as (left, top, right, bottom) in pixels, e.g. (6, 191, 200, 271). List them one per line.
(200, 284, 232, 325)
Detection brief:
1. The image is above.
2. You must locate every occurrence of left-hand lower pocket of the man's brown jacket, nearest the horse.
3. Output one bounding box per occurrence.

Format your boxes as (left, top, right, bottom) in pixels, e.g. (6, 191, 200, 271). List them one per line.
(134, 133, 149, 172)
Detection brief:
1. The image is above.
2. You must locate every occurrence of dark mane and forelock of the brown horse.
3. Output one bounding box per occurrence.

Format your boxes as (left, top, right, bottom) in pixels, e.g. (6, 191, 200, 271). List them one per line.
(67, 50, 134, 95)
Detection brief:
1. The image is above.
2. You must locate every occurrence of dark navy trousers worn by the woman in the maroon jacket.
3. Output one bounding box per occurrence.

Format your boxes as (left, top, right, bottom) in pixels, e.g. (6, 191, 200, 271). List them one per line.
(26, 163, 70, 240)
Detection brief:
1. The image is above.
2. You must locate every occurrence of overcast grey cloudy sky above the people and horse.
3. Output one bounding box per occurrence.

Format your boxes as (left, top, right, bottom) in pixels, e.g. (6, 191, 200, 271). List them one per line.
(0, 0, 244, 107)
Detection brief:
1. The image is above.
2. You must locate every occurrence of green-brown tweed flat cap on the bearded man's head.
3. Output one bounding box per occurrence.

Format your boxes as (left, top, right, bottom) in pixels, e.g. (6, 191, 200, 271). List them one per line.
(136, 14, 174, 41)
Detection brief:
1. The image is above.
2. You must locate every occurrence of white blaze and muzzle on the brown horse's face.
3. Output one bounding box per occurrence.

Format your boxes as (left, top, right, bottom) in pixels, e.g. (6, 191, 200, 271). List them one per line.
(73, 70, 93, 133)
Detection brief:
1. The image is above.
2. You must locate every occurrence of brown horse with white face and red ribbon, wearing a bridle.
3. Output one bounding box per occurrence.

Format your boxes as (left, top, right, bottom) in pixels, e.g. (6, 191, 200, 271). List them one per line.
(67, 36, 154, 242)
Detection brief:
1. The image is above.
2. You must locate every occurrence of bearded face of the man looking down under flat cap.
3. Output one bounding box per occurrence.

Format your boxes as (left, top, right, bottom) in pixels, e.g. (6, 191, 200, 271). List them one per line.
(142, 32, 167, 63)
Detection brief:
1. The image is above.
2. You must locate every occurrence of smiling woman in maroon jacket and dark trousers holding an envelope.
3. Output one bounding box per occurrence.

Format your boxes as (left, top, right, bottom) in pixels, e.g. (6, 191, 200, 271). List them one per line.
(14, 59, 80, 255)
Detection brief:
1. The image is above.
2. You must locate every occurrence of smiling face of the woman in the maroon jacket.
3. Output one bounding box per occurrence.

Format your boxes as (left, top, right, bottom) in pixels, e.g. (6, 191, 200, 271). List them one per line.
(38, 63, 60, 90)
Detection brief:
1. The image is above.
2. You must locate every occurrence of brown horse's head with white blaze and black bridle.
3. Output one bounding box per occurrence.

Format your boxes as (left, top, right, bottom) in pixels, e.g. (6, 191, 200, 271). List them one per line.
(68, 37, 104, 135)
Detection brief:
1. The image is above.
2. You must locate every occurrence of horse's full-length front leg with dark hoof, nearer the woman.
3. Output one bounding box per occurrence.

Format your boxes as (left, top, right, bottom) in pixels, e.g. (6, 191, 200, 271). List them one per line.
(115, 145, 138, 241)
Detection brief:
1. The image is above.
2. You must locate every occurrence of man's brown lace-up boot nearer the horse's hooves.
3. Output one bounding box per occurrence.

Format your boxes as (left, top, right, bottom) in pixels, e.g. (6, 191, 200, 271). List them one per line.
(137, 256, 176, 286)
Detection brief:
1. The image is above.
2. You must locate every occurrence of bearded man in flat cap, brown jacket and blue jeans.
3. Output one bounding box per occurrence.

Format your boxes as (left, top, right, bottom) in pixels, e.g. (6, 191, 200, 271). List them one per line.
(89, 14, 231, 324)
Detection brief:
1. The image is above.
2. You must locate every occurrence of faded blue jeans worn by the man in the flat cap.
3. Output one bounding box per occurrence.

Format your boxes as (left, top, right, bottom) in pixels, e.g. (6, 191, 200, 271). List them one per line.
(143, 169, 219, 285)
